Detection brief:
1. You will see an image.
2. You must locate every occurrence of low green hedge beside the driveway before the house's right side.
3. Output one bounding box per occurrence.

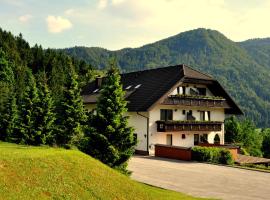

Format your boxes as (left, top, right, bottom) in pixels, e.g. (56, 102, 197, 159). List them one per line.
(191, 147, 233, 165)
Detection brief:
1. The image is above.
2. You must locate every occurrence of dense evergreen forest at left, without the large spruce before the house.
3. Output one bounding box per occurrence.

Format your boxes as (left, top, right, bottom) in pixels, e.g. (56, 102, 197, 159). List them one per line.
(0, 29, 95, 145)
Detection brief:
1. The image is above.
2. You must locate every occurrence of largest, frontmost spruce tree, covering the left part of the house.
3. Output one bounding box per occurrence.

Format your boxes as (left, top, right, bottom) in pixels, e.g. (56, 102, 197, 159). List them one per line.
(82, 64, 136, 172)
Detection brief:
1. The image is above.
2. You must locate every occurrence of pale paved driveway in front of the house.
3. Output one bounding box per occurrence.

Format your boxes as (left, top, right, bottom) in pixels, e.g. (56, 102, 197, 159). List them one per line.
(129, 156, 270, 200)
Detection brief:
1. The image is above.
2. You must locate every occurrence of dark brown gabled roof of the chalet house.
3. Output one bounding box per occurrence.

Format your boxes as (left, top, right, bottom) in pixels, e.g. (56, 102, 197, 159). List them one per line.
(82, 65, 242, 114)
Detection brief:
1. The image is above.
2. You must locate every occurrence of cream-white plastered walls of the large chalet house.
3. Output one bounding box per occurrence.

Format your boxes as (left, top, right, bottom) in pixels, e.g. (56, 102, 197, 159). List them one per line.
(86, 84, 225, 154)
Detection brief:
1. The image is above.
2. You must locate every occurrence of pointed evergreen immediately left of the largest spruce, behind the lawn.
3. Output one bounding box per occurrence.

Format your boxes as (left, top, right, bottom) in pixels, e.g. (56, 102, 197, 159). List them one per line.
(57, 61, 87, 145)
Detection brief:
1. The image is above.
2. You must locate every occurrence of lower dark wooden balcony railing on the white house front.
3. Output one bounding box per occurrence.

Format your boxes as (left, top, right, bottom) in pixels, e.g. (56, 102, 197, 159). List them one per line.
(156, 121, 222, 132)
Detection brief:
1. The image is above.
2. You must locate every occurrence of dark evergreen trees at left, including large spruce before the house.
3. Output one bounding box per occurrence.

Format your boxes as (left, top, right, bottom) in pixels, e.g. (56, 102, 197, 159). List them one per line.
(0, 30, 136, 172)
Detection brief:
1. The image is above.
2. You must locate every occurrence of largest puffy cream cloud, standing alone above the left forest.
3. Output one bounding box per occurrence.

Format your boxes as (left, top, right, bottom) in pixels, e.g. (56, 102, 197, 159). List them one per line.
(46, 15, 72, 33)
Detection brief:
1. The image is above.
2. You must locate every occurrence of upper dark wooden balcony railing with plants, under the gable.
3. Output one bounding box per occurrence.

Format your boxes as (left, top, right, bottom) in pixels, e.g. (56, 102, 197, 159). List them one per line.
(162, 95, 229, 108)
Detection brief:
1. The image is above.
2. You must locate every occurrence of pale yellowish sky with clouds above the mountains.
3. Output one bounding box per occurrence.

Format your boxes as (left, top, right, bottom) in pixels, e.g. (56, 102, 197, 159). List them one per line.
(0, 0, 270, 50)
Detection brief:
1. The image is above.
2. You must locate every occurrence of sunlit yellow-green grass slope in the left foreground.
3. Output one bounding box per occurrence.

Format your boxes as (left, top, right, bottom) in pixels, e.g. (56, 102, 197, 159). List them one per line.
(0, 142, 211, 200)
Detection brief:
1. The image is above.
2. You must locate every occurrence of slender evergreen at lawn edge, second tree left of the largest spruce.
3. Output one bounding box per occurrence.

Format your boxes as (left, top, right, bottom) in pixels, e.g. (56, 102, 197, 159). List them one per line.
(35, 72, 55, 144)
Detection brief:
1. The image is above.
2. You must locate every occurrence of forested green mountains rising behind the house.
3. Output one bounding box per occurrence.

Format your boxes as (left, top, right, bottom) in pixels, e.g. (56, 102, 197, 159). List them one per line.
(61, 28, 270, 127)
